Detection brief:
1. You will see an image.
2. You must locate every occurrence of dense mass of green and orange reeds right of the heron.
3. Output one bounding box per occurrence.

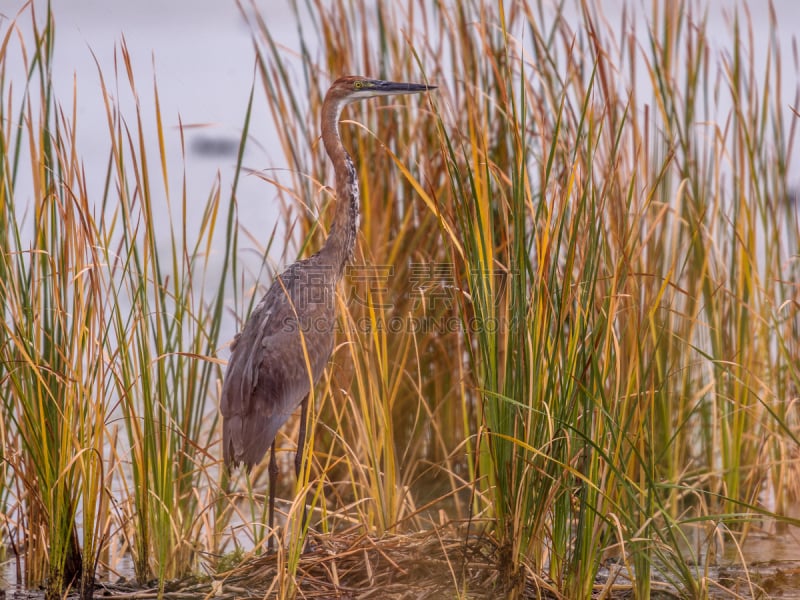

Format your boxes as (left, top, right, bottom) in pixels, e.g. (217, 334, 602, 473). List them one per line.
(247, 1, 796, 597)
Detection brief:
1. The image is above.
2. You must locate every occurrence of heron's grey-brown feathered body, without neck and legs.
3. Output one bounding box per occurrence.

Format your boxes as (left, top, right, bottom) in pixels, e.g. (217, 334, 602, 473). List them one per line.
(222, 254, 338, 469)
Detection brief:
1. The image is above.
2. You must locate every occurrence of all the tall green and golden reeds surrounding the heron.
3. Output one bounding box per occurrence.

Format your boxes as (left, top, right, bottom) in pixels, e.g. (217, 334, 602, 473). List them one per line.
(0, 0, 800, 599)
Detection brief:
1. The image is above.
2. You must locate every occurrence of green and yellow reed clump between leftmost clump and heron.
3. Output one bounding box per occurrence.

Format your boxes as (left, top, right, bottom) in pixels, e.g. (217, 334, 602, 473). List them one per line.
(91, 39, 241, 583)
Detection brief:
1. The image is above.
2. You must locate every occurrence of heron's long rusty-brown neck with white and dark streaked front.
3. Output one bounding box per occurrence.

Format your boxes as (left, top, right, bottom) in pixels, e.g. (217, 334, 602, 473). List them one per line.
(320, 102, 360, 276)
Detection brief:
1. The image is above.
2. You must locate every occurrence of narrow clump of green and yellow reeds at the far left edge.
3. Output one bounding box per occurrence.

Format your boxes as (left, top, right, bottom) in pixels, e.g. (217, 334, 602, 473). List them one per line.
(0, 5, 101, 597)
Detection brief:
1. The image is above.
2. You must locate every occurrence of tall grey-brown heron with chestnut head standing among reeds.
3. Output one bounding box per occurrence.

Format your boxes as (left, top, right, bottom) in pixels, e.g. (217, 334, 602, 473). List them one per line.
(221, 77, 435, 547)
